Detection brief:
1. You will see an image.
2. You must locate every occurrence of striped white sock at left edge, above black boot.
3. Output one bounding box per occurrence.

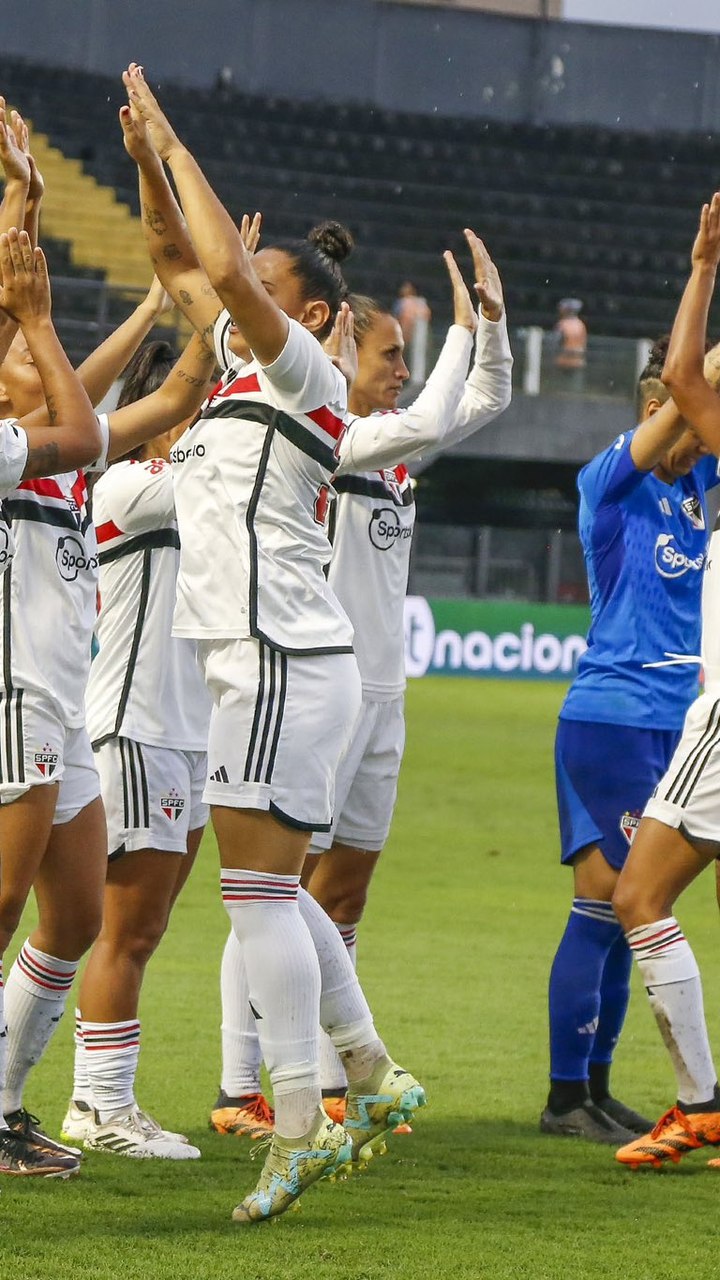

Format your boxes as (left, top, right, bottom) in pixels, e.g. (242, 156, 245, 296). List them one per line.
(3, 942, 78, 1115)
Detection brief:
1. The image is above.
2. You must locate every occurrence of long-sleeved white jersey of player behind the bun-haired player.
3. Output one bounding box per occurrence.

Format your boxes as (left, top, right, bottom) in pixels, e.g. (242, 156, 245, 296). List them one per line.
(328, 315, 512, 701)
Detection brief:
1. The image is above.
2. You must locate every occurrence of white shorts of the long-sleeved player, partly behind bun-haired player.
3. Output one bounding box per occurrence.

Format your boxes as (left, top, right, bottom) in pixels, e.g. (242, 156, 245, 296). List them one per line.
(313, 695, 405, 852)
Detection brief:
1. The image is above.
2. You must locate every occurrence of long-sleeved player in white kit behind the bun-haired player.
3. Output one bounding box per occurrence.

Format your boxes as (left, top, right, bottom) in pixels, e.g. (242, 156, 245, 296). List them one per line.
(210, 230, 512, 1137)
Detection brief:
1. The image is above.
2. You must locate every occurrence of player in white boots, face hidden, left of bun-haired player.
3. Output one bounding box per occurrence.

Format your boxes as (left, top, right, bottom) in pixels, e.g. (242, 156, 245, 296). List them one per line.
(61, 342, 210, 1160)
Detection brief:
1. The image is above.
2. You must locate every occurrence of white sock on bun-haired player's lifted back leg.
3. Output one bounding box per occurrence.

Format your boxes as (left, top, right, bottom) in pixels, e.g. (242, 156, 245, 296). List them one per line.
(297, 888, 387, 1080)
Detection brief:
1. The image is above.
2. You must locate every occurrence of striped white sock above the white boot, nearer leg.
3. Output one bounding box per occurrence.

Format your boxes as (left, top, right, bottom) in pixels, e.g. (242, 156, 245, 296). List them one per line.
(81, 1018, 140, 1124)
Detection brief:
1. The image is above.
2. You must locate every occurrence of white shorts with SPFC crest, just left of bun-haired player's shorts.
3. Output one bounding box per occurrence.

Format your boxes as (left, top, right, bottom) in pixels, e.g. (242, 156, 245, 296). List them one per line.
(95, 737, 208, 861)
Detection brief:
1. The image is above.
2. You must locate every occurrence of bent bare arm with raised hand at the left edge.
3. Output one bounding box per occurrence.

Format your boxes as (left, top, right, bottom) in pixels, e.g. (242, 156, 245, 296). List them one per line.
(0, 227, 101, 477)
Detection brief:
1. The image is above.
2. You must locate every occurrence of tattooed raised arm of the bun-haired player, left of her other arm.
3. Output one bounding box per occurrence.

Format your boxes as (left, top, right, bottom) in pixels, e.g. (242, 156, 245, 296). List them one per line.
(120, 94, 223, 343)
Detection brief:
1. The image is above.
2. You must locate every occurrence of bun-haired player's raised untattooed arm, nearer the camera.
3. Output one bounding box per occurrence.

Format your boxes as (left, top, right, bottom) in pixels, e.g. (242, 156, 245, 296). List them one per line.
(123, 63, 290, 365)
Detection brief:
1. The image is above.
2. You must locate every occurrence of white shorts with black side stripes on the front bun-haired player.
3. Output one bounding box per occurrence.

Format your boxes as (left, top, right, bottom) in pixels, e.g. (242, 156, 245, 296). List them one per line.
(197, 640, 361, 831)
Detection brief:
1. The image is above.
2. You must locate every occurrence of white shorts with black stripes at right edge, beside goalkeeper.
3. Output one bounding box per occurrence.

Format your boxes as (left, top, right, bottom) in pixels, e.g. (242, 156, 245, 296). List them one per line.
(643, 689, 720, 842)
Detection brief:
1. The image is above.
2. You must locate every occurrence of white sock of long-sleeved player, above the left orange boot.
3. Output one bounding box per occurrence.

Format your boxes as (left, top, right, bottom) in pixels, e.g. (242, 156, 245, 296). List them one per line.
(220, 928, 263, 1098)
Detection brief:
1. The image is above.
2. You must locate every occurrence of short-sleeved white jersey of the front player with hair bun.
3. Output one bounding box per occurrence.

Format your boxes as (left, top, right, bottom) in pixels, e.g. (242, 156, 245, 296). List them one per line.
(170, 315, 352, 655)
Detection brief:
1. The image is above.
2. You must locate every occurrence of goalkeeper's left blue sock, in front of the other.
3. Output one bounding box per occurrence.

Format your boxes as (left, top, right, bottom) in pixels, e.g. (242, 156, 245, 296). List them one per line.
(550, 897, 621, 1108)
